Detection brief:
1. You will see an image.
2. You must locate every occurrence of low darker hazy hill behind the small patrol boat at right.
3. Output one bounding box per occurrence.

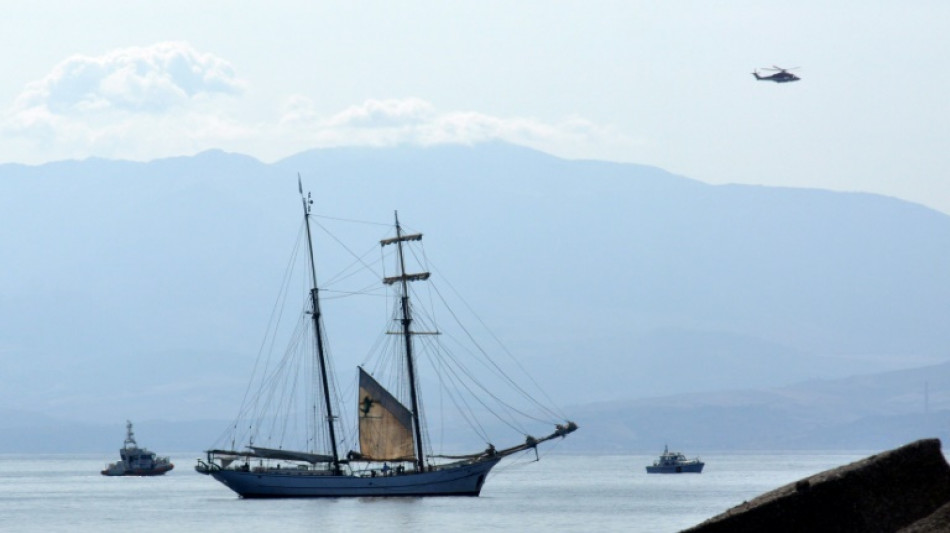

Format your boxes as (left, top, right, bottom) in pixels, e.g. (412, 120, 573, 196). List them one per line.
(572, 364, 950, 451)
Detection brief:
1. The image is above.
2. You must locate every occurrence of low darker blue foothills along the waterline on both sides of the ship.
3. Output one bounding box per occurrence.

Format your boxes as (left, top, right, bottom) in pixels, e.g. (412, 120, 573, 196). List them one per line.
(0, 364, 950, 453)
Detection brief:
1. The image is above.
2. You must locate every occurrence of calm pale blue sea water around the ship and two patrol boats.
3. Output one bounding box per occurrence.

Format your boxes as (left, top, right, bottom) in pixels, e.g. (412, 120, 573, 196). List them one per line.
(0, 452, 871, 533)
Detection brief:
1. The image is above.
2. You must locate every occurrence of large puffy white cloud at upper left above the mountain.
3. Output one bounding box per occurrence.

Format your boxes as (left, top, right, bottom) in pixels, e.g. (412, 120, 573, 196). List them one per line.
(0, 42, 253, 158)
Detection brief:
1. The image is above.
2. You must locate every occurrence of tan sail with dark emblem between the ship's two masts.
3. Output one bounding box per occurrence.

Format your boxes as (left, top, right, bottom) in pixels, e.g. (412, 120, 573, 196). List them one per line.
(358, 368, 415, 461)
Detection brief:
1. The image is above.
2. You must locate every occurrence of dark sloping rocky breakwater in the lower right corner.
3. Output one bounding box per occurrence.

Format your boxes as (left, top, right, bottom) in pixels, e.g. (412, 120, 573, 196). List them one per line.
(684, 439, 950, 533)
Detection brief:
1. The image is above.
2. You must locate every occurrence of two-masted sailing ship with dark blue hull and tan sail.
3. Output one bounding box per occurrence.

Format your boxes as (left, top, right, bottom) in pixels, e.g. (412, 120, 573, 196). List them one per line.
(195, 181, 577, 498)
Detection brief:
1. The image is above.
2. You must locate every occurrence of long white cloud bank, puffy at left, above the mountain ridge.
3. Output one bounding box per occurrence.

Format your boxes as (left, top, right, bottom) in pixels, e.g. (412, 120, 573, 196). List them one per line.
(0, 42, 632, 162)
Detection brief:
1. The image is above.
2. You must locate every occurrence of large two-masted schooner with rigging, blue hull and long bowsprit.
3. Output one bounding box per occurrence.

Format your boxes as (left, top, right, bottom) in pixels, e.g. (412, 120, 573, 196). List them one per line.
(195, 178, 577, 498)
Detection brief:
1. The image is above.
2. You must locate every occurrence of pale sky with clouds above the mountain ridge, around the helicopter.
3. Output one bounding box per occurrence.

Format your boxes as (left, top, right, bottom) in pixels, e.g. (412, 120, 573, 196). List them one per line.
(0, 0, 950, 213)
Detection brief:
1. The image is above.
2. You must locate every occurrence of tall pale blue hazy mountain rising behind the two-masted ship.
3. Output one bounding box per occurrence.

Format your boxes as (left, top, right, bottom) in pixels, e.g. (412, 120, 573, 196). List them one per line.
(0, 144, 950, 444)
